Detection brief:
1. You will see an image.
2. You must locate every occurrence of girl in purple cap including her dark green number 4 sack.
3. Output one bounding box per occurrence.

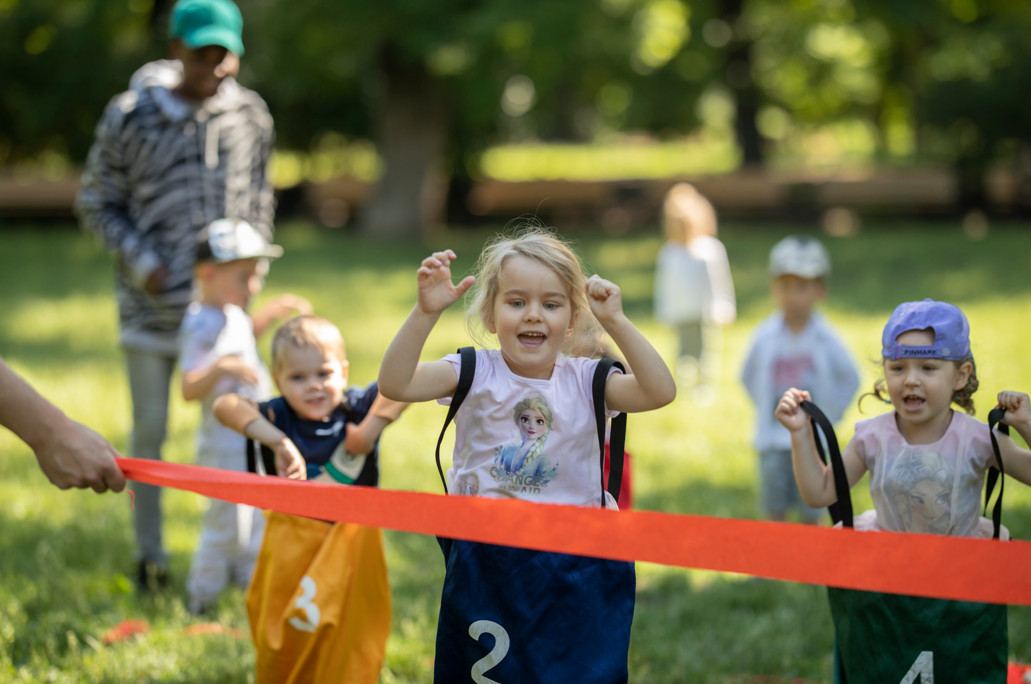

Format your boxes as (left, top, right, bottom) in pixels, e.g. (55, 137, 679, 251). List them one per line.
(775, 299, 1031, 684)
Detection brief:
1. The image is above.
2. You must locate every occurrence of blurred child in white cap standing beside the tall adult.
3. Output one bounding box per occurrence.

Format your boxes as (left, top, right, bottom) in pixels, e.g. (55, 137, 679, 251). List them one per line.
(179, 219, 311, 613)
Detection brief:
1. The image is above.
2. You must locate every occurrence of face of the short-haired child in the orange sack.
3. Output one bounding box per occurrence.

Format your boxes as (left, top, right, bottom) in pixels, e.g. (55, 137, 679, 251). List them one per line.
(274, 346, 347, 421)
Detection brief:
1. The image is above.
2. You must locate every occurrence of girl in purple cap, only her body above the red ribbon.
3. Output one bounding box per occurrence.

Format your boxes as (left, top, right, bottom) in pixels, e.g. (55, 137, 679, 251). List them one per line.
(776, 299, 1031, 538)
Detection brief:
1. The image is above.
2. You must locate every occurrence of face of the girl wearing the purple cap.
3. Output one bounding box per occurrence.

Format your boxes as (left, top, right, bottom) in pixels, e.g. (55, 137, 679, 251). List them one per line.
(884, 330, 973, 444)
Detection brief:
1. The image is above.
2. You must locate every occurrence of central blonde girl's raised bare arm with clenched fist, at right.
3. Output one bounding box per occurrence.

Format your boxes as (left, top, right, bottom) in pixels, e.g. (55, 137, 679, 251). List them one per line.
(587, 275, 676, 413)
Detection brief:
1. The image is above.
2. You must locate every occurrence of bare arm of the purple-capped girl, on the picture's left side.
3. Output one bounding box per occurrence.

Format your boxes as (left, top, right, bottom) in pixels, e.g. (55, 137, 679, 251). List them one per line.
(775, 388, 866, 508)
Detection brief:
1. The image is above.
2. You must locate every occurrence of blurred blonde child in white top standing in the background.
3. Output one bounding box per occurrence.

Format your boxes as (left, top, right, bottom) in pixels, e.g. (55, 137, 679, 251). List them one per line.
(655, 183, 737, 404)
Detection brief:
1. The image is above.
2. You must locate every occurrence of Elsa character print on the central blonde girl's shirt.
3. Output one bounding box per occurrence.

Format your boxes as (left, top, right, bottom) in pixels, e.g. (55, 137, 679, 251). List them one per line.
(491, 397, 557, 494)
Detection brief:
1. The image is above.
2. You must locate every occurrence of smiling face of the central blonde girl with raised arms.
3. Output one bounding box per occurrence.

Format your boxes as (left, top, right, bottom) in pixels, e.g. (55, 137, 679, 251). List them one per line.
(487, 255, 573, 380)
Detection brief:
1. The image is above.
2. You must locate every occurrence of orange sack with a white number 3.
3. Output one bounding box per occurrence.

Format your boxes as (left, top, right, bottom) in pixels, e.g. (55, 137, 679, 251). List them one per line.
(246, 512, 391, 684)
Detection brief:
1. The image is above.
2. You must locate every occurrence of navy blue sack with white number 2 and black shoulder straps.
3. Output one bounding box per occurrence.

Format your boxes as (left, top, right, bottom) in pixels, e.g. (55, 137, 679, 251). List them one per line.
(433, 348, 636, 684)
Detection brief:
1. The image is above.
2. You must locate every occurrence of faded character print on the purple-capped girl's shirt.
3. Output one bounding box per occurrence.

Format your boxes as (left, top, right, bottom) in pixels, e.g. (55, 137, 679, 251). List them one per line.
(889, 450, 955, 534)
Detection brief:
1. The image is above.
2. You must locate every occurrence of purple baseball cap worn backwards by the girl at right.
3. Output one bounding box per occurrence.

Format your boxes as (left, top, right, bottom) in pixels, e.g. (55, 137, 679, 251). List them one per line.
(880, 299, 971, 361)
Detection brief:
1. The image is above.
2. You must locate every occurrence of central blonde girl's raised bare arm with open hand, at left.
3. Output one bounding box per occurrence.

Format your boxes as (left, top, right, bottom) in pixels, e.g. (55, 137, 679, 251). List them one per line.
(378, 250, 474, 401)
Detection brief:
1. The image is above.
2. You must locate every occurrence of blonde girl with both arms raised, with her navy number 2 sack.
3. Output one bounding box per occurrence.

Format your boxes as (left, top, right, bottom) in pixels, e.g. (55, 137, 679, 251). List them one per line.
(379, 228, 676, 682)
